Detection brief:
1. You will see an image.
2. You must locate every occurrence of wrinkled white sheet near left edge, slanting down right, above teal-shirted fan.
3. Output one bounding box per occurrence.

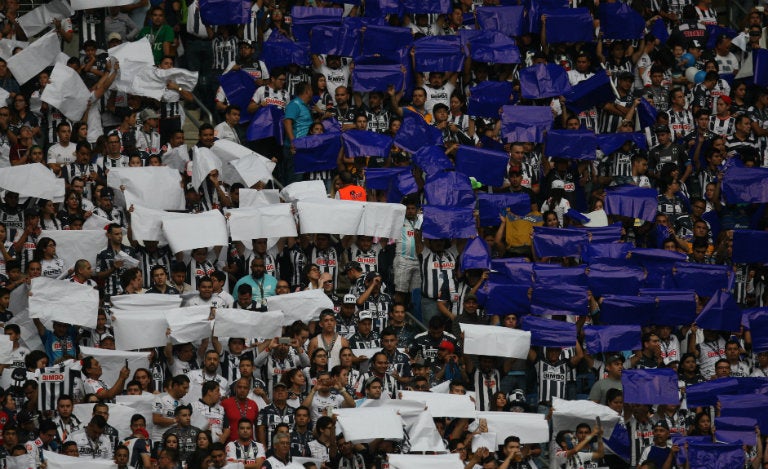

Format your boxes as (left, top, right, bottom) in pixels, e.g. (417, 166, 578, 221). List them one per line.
(29, 277, 99, 329)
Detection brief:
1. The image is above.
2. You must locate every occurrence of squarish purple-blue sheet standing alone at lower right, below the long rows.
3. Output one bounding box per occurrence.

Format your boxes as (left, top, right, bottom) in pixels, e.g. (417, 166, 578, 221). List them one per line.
(621, 368, 680, 405)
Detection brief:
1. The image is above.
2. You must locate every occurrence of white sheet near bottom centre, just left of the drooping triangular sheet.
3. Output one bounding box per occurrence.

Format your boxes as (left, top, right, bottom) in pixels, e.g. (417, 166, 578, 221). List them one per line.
(333, 407, 403, 443)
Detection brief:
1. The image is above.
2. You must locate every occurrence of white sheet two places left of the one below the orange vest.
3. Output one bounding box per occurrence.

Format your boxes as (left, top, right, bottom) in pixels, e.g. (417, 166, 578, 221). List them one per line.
(163, 210, 229, 253)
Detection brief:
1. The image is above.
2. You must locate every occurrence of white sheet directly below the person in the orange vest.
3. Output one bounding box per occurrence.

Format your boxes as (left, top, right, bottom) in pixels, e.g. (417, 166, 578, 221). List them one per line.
(296, 199, 364, 234)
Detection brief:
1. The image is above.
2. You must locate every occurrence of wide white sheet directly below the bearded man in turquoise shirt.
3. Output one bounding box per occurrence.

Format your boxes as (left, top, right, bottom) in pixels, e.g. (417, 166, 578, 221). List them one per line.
(213, 308, 285, 339)
